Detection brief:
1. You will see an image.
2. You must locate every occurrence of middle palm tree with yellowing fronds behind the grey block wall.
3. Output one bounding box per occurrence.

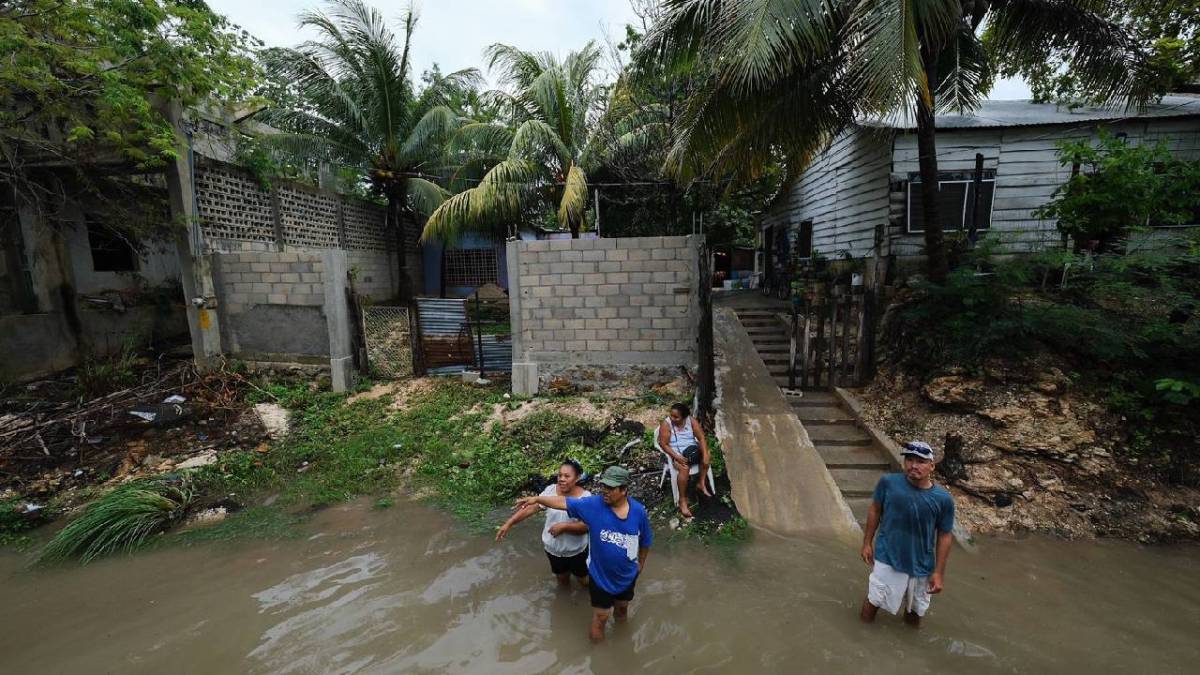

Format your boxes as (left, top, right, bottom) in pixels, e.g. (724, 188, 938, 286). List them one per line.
(421, 42, 604, 241)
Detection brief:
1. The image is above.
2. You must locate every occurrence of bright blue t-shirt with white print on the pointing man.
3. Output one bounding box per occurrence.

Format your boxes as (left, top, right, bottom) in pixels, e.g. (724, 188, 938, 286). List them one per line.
(566, 495, 654, 595)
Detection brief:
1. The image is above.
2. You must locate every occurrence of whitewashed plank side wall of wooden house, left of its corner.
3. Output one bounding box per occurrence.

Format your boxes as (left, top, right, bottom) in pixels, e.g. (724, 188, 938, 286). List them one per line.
(761, 129, 890, 257)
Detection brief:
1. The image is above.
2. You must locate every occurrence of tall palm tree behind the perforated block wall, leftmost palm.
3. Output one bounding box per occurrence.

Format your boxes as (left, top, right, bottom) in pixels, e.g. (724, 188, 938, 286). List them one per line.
(263, 0, 480, 297)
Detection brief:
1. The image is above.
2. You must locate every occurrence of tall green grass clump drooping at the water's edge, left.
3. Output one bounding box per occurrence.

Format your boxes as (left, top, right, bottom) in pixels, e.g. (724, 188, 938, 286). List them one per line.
(37, 478, 193, 563)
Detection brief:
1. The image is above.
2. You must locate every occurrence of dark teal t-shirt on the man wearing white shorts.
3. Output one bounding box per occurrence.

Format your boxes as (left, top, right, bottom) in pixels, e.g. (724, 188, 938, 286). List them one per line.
(871, 473, 954, 577)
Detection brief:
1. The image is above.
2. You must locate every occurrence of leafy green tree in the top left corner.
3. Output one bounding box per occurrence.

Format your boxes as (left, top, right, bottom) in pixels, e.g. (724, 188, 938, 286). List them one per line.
(0, 0, 257, 229)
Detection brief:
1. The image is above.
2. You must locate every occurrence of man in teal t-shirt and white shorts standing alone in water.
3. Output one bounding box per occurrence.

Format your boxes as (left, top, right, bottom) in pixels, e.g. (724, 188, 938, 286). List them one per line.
(860, 441, 954, 627)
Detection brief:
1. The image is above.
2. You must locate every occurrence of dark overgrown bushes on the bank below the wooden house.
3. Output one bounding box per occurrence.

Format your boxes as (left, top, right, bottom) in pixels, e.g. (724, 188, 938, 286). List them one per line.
(884, 238, 1200, 483)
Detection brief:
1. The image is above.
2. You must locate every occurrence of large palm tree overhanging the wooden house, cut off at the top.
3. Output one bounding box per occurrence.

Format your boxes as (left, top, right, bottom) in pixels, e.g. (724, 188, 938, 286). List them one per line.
(646, 0, 1148, 281)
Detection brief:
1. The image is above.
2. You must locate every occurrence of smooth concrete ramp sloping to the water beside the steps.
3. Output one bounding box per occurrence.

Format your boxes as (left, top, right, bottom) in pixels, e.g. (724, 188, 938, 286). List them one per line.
(713, 306, 862, 538)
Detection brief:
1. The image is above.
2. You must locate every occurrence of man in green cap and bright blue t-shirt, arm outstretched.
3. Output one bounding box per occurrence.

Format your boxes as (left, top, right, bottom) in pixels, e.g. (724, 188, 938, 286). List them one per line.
(517, 466, 654, 643)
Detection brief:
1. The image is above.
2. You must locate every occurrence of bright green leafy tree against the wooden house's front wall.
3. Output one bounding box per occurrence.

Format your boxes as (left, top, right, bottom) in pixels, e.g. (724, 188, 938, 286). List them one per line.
(1034, 133, 1200, 250)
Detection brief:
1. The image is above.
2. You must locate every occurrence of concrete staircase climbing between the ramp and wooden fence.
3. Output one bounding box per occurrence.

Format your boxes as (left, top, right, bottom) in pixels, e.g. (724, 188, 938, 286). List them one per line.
(736, 302, 892, 524)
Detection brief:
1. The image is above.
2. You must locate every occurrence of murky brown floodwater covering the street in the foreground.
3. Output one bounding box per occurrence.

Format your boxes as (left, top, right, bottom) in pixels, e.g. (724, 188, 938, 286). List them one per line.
(0, 503, 1200, 675)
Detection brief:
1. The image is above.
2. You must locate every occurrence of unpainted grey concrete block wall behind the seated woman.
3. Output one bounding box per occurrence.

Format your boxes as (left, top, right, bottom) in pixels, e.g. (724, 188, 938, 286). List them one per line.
(508, 235, 703, 393)
